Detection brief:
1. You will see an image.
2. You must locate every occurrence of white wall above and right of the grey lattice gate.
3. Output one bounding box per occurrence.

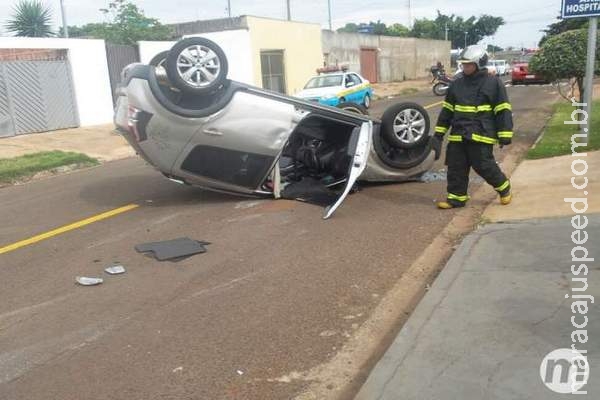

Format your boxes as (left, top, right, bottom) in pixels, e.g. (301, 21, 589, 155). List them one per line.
(0, 37, 113, 126)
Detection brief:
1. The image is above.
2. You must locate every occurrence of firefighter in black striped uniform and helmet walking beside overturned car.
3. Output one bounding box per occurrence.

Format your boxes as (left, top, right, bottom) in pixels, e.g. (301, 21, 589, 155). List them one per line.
(434, 46, 513, 209)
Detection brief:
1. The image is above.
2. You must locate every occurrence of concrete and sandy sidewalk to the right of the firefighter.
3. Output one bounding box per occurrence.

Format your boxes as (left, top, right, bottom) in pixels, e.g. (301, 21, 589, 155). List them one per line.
(355, 152, 600, 400)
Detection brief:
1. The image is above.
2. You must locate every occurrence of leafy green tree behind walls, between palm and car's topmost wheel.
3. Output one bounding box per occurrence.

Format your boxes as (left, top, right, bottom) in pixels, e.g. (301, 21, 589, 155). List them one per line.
(69, 0, 173, 45)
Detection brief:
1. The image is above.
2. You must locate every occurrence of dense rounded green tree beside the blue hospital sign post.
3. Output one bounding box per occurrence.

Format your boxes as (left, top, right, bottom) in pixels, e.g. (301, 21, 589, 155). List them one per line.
(529, 29, 587, 103)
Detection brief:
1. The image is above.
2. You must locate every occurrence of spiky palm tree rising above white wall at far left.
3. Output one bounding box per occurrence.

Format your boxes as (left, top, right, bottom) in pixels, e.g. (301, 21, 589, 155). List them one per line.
(6, 0, 54, 37)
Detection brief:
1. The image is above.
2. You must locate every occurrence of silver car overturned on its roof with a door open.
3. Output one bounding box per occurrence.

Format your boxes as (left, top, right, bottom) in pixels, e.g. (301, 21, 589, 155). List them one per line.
(115, 37, 439, 218)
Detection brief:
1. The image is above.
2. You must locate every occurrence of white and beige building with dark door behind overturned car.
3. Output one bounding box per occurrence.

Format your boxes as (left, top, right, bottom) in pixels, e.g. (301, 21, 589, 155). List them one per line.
(173, 16, 323, 95)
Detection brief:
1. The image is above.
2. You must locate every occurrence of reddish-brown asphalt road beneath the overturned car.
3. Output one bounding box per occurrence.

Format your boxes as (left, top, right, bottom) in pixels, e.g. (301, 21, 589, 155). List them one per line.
(0, 83, 555, 400)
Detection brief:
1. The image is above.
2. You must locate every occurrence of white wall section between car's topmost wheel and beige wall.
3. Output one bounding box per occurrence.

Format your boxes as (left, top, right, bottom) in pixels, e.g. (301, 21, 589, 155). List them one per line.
(180, 29, 251, 86)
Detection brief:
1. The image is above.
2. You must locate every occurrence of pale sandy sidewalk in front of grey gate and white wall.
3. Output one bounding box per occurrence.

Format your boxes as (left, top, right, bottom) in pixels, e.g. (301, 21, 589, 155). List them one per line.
(0, 125, 135, 162)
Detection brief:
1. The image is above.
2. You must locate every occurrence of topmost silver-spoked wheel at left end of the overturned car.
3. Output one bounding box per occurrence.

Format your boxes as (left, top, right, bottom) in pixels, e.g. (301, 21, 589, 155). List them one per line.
(166, 37, 228, 95)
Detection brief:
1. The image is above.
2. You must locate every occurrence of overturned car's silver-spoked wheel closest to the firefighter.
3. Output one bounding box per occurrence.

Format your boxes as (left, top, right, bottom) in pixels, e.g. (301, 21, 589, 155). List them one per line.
(381, 103, 430, 149)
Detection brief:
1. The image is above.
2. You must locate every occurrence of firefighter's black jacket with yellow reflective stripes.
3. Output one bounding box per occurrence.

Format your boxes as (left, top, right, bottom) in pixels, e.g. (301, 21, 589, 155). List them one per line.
(435, 69, 513, 144)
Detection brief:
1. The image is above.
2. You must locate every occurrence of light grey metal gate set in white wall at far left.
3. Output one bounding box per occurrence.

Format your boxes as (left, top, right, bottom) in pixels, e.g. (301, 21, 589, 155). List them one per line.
(0, 60, 79, 137)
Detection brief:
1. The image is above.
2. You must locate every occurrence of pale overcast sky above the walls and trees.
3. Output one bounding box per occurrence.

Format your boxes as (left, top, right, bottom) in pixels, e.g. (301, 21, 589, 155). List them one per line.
(0, 0, 561, 47)
